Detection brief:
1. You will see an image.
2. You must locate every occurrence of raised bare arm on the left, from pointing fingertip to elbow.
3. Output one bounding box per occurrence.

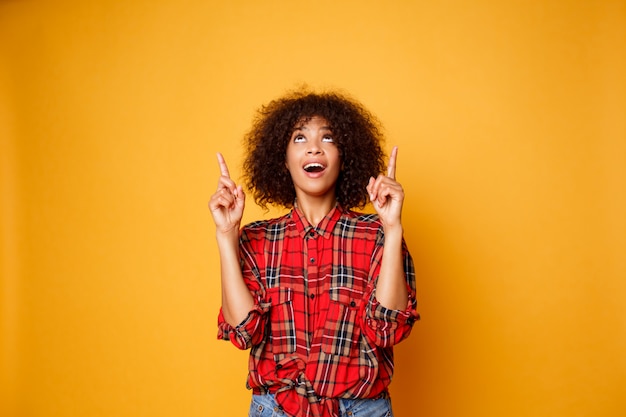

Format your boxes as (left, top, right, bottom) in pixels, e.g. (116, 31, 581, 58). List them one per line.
(209, 153, 254, 327)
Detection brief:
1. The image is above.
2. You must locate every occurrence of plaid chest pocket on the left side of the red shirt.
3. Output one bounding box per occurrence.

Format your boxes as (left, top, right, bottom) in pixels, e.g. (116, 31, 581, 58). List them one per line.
(266, 287, 296, 354)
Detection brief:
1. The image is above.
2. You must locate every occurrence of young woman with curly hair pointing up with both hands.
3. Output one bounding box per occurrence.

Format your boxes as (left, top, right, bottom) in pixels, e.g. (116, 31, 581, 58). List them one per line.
(209, 92, 419, 417)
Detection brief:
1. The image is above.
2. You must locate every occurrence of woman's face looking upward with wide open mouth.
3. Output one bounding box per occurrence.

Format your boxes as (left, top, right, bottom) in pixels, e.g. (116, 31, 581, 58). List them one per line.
(285, 116, 341, 200)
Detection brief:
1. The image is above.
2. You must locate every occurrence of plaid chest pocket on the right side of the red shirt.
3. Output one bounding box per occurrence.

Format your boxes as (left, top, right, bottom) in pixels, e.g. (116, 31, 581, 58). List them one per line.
(322, 287, 363, 356)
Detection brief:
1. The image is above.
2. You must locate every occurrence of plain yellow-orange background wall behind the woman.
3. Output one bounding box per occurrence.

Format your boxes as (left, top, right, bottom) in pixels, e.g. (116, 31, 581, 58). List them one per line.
(0, 0, 626, 417)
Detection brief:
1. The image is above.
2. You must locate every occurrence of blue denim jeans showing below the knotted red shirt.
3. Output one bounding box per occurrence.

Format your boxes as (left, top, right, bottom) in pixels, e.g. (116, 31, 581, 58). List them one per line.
(248, 394, 393, 417)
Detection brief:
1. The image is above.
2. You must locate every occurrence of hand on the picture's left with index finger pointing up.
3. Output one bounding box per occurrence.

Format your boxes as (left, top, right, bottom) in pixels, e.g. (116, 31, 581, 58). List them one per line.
(209, 152, 246, 236)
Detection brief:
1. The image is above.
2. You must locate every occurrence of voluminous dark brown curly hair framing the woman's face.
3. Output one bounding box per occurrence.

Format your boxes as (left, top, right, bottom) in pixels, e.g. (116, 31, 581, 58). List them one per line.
(243, 89, 385, 209)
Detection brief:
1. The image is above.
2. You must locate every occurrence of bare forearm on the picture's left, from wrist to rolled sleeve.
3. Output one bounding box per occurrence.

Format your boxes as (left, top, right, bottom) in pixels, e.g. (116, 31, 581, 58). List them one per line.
(217, 232, 254, 327)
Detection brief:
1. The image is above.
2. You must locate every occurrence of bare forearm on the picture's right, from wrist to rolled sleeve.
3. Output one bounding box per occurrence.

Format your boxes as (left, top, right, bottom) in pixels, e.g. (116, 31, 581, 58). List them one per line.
(376, 225, 409, 310)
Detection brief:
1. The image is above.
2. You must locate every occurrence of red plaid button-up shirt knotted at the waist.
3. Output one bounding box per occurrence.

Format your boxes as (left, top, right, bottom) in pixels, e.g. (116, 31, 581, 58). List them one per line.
(218, 206, 419, 417)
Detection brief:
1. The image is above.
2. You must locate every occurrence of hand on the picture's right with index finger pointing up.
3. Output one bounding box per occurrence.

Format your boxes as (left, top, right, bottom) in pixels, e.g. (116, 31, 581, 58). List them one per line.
(367, 146, 404, 230)
